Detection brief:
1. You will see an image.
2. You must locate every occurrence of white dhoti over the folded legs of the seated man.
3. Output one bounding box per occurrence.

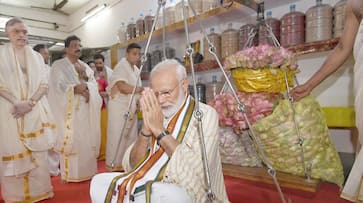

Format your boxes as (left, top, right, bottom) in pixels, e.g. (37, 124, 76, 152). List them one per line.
(90, 173, 193, 203)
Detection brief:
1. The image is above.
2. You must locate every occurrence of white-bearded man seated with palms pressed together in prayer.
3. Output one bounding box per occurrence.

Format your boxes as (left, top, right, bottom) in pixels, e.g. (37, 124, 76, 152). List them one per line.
(90, 60, 229, 203)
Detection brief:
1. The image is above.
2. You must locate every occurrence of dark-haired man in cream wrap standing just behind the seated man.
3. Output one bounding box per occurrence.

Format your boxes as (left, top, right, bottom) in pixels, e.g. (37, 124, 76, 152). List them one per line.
(106, 43, 143, 171)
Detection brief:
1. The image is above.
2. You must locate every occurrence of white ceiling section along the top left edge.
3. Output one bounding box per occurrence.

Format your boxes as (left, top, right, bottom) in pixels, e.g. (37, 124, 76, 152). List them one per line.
(0, 0, 91, 15)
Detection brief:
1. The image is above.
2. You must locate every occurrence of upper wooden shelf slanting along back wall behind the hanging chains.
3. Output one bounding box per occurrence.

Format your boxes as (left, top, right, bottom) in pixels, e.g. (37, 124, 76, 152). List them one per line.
(113, 0, 257, 49)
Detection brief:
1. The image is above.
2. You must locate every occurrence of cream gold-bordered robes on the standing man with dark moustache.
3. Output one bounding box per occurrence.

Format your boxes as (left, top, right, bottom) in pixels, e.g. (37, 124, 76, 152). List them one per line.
(48, 57, 102, 182)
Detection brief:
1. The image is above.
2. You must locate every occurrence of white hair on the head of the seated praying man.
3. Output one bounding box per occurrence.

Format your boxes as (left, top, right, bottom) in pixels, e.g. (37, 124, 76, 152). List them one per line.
(150, 59, 187, 81)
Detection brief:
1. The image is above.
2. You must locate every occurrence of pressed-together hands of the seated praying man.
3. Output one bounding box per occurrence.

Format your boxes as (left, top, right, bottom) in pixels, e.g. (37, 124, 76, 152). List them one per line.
(140, 88, 164, 135)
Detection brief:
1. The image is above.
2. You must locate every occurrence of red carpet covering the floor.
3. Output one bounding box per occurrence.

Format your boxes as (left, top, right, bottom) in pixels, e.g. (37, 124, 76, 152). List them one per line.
(0, 161, 348, 203)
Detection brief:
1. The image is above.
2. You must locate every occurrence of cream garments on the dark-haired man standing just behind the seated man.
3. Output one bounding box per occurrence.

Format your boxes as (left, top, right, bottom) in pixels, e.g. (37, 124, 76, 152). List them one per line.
(106, 58, 141, 170)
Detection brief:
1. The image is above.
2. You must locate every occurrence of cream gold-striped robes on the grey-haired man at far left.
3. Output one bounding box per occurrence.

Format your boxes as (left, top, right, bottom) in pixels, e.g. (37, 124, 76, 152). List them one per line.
(0, 44, 55, 202)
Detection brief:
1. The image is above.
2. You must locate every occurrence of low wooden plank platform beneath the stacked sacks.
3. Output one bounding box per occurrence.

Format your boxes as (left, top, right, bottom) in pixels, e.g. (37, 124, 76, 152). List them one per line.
(223, 164, 320, 192)
